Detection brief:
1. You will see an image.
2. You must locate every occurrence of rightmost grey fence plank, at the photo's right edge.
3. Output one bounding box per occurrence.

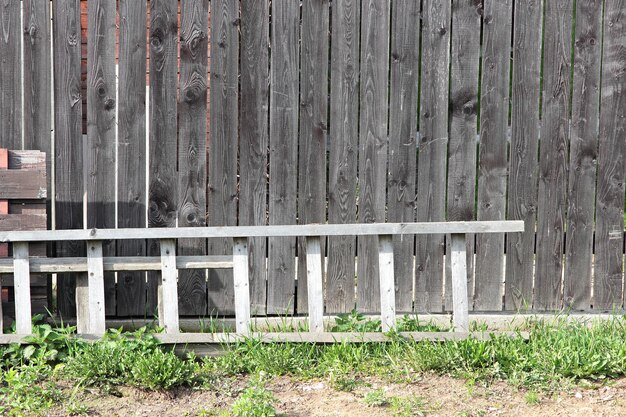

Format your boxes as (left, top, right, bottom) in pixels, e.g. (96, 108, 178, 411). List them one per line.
(593, 0, 626, 310)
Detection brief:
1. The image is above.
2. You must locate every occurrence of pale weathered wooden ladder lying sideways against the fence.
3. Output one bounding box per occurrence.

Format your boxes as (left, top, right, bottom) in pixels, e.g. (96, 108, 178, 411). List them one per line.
(0, 221, 524, 343)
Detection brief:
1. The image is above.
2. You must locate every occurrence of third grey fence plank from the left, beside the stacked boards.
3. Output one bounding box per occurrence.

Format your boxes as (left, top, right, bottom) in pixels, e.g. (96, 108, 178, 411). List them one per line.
(52, 0, 85, 317)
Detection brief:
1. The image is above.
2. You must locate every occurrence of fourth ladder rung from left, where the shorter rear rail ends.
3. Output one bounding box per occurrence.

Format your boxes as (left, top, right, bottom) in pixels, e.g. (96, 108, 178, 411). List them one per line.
(233, 238, 250, 334)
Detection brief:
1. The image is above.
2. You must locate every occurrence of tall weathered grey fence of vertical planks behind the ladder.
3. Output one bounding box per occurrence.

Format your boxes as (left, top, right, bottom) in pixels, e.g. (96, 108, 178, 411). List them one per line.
(0, 0, 626, 317)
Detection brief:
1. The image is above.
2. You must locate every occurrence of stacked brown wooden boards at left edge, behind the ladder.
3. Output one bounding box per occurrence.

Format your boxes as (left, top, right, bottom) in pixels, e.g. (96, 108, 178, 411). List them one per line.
(0, 149, 48, 323)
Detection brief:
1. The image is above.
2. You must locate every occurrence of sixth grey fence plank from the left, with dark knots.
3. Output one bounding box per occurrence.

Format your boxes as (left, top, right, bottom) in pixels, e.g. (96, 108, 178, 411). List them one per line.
(147, 0, 178, 311)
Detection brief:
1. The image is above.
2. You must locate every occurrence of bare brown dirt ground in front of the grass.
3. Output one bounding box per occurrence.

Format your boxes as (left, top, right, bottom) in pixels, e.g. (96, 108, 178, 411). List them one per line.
(49, 375, 626, 417)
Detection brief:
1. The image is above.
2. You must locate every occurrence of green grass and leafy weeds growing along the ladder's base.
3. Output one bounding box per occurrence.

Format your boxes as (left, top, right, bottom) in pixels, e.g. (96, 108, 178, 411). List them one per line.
(0, 312, 626, 416)
